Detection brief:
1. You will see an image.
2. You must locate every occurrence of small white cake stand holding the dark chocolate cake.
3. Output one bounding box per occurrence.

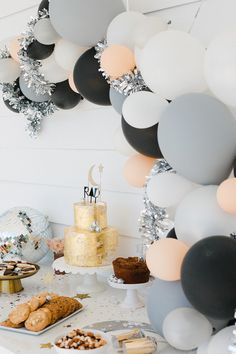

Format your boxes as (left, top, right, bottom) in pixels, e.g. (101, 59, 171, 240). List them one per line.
(107, 277, 153, 310)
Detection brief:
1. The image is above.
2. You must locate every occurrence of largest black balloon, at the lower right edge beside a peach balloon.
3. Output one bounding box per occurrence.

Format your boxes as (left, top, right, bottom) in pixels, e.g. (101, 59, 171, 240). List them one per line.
(181, 236, 236, 319)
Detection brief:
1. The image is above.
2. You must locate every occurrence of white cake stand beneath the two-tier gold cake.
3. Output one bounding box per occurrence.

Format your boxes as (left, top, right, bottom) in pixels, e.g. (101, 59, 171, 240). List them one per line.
(53, 257, 112, 294)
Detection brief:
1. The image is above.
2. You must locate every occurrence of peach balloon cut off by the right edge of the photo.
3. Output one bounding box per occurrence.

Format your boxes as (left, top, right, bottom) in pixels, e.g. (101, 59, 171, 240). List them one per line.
(217, 178, 236, 214)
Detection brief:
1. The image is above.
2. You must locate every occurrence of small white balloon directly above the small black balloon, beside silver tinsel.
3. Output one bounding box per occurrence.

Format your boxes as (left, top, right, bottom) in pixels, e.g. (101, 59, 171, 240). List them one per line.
(40, 54, 69, 83)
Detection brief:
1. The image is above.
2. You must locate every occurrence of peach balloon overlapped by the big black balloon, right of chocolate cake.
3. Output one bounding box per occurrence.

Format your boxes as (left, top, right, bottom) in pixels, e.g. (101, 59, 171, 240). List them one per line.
(146, 238, 189, 281)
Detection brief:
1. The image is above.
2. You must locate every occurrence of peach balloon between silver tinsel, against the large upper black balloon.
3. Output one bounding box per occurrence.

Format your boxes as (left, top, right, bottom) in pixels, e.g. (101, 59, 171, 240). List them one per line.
(101, 44, 136, 79)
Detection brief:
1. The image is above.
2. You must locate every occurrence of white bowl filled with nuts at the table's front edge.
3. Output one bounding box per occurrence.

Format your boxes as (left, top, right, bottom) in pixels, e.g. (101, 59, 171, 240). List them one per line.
(54, 329, 111, 354)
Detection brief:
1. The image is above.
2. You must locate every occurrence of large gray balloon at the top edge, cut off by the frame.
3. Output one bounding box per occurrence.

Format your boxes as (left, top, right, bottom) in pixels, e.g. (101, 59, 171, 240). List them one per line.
(49, 0, 125, 47)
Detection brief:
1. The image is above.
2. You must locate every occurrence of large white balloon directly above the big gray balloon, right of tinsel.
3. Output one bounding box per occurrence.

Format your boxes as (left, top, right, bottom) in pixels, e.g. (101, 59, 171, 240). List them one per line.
(140, 30, 207, 99)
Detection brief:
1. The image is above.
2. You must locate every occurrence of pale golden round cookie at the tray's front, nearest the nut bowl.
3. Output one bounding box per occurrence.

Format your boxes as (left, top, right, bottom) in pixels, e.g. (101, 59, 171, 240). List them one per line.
(25, 309, 51, 332)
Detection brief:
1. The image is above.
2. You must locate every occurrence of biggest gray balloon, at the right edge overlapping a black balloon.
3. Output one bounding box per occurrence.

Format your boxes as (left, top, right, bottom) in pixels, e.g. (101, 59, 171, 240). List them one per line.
(158, 93, 236, 185)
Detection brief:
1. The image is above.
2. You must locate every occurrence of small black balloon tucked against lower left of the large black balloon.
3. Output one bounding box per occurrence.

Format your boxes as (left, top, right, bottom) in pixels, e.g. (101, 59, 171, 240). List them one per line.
(52, 80, 81, 109)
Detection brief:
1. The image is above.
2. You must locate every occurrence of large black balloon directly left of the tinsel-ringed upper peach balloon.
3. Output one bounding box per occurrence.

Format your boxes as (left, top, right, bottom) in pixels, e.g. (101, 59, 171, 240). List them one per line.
(74, 48, 111, 106)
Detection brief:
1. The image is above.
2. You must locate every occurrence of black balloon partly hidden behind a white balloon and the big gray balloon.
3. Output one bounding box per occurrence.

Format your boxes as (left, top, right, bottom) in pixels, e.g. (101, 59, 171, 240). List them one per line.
(122, 117, 163, 158)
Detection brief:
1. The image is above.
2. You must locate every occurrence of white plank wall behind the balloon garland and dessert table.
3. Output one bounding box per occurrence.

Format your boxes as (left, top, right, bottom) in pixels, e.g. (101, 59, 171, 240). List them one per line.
(0, 0, 233, 255)
